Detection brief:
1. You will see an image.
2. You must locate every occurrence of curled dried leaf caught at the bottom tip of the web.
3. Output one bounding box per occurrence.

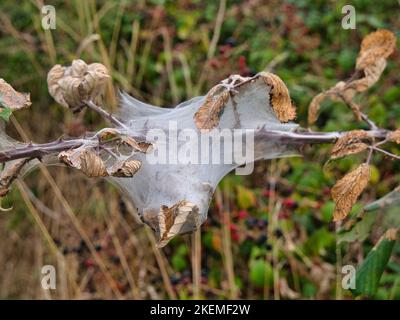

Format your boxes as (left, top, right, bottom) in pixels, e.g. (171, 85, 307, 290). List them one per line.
(158, 200, 200, 247)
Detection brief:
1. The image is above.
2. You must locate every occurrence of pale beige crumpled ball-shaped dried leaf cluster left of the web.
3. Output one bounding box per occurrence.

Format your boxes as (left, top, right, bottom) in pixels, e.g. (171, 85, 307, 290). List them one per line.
(47, 59, 110, 109)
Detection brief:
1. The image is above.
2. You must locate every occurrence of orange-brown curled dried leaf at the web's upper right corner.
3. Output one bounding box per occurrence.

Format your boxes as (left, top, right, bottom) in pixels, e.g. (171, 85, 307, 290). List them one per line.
(259, 72, 296, 122)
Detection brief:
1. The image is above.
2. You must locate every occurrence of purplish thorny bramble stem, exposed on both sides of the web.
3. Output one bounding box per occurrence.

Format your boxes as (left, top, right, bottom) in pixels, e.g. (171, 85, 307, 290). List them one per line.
(0, 129, 389, 163)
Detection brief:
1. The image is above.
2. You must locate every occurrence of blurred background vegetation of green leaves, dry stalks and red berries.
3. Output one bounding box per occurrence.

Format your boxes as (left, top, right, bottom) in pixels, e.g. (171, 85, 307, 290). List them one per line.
(0, 0, 400, 299)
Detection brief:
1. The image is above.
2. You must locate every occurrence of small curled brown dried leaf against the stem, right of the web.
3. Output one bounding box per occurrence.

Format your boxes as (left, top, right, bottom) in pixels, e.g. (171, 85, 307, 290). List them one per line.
(331, 130, 371, 159)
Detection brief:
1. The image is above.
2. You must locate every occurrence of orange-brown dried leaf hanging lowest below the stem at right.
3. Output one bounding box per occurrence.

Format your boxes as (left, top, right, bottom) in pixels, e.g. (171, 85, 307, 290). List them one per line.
(331, 163, 370, 221)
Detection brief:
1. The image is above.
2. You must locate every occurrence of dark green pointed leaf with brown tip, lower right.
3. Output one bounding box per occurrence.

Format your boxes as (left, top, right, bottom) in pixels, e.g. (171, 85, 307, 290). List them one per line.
(351, 229, 397, 297)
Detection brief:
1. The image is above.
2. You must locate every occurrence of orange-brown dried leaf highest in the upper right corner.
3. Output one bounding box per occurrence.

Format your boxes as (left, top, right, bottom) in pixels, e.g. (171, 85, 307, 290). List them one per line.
(356, 29, 396, 70)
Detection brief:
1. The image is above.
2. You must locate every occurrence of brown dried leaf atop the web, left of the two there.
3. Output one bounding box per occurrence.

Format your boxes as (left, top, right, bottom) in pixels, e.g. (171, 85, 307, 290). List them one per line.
(194, 85, 229, 130)
